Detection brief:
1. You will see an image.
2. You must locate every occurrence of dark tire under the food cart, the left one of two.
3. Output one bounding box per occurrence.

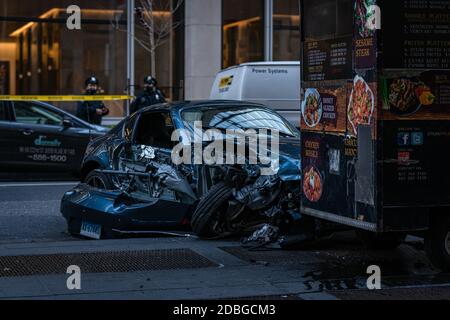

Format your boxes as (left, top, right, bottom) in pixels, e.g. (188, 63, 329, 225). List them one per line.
(356, 230, 406, 250)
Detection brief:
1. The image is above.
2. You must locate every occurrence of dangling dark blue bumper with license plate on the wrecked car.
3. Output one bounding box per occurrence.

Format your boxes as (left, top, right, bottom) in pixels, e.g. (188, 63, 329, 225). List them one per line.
(61, 184, 190, 239)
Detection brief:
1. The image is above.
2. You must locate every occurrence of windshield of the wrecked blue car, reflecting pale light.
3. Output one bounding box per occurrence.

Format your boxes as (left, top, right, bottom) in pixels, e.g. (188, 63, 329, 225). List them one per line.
(182, 106, 299, 137)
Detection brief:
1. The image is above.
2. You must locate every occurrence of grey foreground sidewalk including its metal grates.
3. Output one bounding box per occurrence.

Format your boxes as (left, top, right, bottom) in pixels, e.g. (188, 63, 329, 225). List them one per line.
(0, 238, 442, 300)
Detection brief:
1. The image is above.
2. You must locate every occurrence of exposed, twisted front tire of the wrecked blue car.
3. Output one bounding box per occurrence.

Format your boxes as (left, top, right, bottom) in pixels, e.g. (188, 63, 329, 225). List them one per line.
(191, 182, 232, 238)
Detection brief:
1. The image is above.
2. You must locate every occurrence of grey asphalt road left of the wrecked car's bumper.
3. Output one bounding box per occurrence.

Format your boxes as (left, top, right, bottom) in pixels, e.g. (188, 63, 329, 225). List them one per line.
(0, 182, 76, 243)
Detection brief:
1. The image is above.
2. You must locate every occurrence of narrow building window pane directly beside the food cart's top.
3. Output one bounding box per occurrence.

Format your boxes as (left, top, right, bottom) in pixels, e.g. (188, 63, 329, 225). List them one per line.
(273, 0, 300, 61)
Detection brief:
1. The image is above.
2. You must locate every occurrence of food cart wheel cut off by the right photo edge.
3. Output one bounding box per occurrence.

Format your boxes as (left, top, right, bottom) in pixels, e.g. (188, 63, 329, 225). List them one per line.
(425, 217, 450, 272)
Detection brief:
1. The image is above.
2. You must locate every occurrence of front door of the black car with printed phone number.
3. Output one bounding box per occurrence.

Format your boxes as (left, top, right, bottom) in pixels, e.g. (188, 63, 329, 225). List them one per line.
(13, 101, 89, 172)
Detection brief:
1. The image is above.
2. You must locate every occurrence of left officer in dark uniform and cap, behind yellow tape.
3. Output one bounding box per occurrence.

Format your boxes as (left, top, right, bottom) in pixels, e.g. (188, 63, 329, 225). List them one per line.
(77, 76, 109, 125)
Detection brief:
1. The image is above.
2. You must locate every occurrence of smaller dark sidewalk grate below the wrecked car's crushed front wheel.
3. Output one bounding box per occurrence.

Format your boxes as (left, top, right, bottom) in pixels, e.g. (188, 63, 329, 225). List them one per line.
(220, 247, 323, 265)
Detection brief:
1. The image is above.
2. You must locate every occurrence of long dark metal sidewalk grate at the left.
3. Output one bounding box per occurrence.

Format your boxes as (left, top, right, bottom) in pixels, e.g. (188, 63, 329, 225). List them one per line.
(0, 249, 218, 277)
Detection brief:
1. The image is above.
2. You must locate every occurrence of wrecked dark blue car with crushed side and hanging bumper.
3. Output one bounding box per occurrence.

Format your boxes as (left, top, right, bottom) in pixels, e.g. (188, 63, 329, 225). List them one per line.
(61, 101, 300, 239)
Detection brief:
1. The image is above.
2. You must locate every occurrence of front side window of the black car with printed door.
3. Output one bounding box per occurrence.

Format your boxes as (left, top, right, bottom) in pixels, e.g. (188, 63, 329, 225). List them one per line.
(14, 102, 63, 126)
